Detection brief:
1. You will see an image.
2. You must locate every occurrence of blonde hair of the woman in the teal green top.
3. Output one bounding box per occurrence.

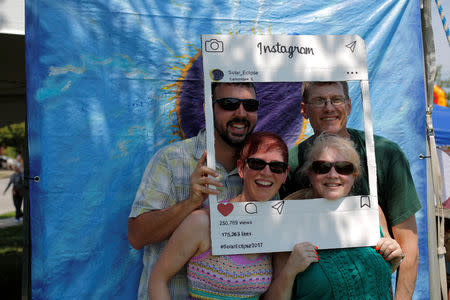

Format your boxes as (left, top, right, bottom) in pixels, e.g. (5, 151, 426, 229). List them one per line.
(302, 133, 361, 176)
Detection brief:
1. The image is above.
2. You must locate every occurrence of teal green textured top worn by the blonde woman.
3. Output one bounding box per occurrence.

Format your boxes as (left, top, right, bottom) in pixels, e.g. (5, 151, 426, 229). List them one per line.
(292, 247, 391, 300)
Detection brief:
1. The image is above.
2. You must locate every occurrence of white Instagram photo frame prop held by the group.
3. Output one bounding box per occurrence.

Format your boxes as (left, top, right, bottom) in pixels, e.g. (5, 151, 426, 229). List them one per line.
(202, 35, 380, 255)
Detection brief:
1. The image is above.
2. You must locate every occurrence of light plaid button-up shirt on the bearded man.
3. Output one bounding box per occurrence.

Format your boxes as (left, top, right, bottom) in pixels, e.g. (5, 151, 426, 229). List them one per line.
(130, 130, 242, 300)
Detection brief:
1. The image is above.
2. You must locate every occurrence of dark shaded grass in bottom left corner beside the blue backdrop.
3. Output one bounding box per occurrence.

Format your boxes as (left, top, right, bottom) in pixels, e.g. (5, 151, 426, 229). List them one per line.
(0, 224, 23, 299)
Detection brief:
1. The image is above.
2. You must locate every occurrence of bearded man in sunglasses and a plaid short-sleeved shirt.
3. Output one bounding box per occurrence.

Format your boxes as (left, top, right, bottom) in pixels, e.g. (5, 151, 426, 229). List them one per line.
(128, 83, 259, 299)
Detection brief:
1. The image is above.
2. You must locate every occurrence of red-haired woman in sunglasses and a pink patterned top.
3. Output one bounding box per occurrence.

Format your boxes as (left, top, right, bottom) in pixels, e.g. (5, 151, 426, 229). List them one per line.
(149, 132, 288, 299)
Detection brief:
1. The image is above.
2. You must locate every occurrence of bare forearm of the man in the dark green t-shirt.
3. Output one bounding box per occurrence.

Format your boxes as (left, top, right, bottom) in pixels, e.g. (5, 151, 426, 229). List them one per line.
(392, 215, 419, 299)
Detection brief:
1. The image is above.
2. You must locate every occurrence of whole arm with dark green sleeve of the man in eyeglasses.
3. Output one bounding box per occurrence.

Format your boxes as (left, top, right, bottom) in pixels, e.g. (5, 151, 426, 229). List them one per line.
(375, 137, 421, 299)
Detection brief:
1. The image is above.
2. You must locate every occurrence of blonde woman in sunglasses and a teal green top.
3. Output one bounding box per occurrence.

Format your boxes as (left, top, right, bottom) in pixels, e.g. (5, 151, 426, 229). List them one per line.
(264, 134, 403, 299)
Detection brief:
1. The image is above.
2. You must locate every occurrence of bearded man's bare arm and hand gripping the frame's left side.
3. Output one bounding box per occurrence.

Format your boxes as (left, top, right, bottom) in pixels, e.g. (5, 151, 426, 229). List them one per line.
(128, 151, 222, 249)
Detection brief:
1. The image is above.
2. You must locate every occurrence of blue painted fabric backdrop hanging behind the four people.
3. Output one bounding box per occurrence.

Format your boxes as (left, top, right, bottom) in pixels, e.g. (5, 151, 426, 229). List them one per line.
(26, 0, 428, 299)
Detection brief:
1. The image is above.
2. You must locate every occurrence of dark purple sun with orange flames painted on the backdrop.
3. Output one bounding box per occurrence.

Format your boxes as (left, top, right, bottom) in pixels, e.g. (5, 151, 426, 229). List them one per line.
(162, 31, 308, 147)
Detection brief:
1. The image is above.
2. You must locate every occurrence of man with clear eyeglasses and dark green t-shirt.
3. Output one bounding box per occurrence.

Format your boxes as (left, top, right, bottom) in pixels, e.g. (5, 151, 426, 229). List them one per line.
(282, 81, 421, 299)
